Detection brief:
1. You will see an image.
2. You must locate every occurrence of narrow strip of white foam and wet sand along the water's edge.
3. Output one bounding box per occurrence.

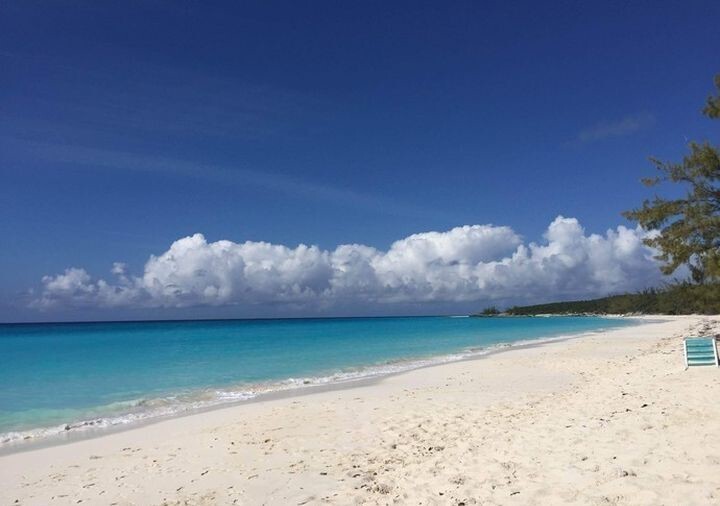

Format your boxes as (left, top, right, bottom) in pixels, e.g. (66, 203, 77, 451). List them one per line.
(0, 315, 644, 456)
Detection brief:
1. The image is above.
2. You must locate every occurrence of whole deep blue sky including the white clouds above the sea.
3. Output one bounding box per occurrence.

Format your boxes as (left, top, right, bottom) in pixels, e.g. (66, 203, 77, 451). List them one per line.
(0, 0, 720, 322)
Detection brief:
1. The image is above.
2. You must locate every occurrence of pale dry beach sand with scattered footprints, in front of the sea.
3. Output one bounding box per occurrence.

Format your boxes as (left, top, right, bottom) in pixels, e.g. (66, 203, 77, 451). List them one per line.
(0, 317, 720, 506)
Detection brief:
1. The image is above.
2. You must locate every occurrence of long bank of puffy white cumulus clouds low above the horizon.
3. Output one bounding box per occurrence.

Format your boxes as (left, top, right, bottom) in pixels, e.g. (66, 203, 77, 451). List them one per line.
(33, 216, 661, 310)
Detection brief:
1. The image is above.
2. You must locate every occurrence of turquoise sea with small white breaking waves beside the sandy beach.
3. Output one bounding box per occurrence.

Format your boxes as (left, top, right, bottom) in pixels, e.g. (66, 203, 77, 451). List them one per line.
(0, 317, 632, 443)
